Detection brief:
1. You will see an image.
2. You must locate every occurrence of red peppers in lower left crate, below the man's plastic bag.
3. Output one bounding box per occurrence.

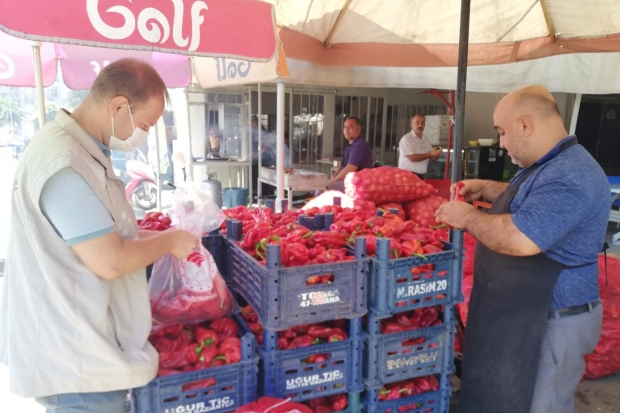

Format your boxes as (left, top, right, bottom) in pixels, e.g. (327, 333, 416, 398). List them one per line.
(149, 317, 241, 376)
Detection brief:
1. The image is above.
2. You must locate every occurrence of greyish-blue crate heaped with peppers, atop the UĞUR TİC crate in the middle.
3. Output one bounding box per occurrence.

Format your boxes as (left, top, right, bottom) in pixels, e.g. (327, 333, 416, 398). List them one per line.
(226, 220, 369, 330)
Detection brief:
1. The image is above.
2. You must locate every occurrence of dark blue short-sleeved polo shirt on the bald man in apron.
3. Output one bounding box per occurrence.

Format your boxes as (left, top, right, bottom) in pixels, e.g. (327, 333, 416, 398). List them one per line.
(510, 136, 611, 310)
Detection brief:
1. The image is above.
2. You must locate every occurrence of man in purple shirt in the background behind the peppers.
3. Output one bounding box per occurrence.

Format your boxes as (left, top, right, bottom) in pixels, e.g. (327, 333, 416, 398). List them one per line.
(327, 116, 373, 191)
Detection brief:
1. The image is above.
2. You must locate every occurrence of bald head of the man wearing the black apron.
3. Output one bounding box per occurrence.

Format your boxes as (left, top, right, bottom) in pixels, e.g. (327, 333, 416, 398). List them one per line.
(493, 85, 568, 167)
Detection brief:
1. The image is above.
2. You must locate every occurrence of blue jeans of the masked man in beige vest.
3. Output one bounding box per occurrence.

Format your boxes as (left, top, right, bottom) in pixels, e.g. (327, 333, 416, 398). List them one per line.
(35, 390, 127, 413)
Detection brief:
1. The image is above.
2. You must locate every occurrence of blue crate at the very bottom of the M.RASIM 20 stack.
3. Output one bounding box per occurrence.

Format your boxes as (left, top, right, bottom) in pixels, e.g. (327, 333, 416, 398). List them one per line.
(362, 375, 452, 413)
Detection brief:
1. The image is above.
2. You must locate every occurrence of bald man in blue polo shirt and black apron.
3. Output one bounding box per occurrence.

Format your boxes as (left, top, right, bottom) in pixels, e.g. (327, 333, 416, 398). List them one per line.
(436, 86, 611, 413)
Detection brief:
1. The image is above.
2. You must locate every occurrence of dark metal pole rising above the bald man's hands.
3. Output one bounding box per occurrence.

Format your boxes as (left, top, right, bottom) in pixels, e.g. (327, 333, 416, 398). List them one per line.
(452, 0, 471, 183)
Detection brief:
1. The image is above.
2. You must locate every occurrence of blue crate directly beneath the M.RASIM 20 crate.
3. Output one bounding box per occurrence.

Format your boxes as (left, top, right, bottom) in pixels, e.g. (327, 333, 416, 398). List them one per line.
(362, 305, 455, 390)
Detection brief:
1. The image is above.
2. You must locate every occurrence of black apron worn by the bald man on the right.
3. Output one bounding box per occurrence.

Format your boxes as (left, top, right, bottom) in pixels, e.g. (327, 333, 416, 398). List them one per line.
(459, 138, 588, 413)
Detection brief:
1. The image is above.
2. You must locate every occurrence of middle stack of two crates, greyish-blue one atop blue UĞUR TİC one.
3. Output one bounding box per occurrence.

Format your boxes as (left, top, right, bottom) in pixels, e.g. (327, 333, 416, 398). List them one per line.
(226, 220, 369, 413)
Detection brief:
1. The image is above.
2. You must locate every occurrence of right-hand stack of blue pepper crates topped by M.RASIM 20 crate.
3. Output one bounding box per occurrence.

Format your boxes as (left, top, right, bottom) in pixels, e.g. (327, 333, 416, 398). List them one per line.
(362, 233, 463, 413)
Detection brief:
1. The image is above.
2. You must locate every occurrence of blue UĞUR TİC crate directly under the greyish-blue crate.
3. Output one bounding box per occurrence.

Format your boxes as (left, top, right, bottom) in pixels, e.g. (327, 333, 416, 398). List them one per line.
(237, 318, 364, 401)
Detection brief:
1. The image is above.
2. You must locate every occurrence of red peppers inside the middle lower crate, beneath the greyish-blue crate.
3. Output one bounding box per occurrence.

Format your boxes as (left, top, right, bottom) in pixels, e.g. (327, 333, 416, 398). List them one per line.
(241, 304, 349, 348)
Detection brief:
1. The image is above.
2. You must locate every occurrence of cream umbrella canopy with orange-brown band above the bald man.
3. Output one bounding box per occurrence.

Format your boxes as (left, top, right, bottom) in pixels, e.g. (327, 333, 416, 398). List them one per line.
(269, 0, 620, 67)
